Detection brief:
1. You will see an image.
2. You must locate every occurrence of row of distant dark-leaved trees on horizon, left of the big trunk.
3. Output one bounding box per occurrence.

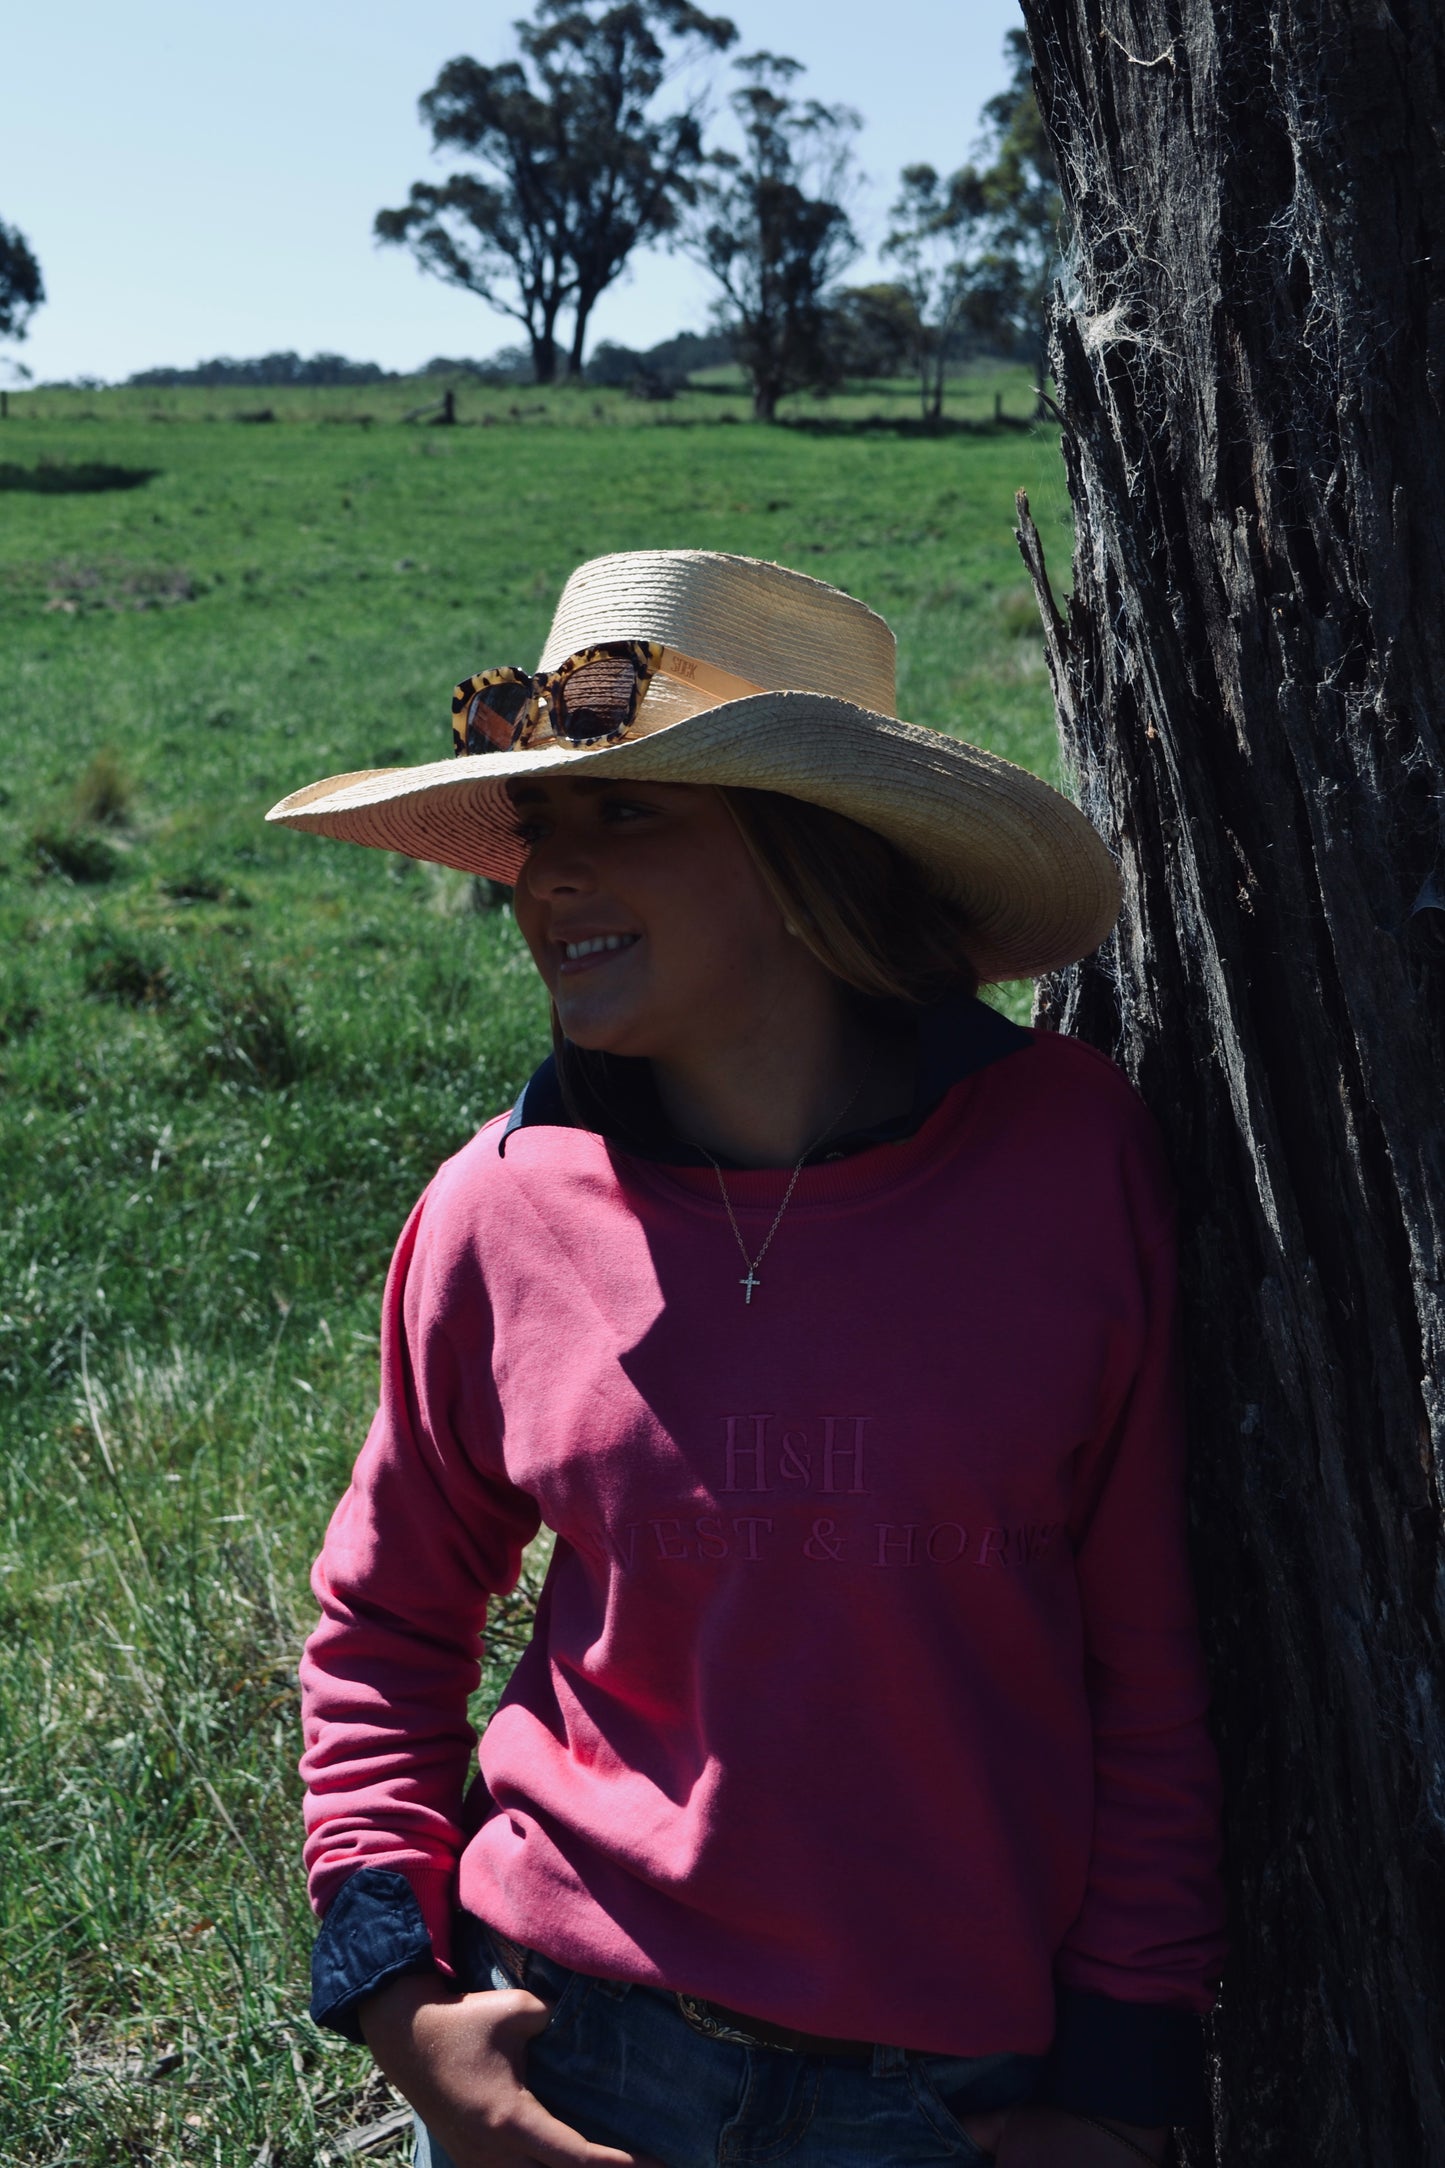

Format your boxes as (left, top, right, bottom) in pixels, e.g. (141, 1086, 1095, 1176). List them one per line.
(375, 0, 1059, 421)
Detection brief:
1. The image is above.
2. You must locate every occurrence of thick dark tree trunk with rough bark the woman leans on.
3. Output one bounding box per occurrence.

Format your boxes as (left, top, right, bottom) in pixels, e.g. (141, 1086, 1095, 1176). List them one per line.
(1023, 0, 1445, 2168)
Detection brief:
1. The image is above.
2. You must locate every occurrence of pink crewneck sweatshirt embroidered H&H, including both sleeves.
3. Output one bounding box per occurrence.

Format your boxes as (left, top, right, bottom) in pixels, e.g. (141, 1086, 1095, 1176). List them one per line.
(301, 1032, 1222, 2055)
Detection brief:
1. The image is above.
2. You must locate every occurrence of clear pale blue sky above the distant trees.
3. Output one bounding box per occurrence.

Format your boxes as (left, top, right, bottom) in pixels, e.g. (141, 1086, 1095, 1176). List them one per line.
(0, 0, 1020, 382)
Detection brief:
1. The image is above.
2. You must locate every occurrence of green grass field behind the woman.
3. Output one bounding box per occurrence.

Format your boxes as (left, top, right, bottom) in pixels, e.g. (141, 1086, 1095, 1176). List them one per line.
(0, 373, 1068, 2168)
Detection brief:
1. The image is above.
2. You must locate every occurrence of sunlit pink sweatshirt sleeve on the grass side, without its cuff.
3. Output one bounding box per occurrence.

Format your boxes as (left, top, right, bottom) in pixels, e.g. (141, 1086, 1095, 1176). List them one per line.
(301, 1184, 539, 1971)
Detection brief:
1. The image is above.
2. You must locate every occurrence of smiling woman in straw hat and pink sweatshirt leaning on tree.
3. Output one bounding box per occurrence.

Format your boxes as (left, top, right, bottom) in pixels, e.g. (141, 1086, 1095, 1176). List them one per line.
(273, 551, 1220, 2168)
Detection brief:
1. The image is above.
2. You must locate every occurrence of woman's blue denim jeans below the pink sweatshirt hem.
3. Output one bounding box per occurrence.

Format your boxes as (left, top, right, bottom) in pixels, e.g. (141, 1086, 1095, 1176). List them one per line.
(416, 1930, 1042, 2168)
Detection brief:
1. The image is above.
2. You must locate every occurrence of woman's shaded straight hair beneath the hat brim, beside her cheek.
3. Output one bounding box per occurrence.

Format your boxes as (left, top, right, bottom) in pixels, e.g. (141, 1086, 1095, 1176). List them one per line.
(717, 789, 979, 1008)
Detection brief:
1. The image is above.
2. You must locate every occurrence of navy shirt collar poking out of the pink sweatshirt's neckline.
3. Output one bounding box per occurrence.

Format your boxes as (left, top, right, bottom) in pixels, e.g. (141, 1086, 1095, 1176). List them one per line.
(496, 993, 1033, 1166)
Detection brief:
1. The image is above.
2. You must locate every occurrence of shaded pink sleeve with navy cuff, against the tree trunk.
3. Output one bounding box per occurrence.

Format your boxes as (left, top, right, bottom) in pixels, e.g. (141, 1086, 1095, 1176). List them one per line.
(1051, 1117, 1224, 2122)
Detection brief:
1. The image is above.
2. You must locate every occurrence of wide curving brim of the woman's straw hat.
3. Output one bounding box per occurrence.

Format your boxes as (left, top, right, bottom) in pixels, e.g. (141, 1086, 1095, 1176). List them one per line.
(266, 692, 1120, 982)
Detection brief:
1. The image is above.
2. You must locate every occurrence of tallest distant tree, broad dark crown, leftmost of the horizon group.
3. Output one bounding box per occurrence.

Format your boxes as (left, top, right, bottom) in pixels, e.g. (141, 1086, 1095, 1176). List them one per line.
(375, 0, 737, 384)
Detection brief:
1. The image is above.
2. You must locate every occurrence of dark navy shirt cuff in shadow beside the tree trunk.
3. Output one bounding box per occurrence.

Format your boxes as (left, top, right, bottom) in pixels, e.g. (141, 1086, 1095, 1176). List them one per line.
(1038, 1986, 1209, 2129)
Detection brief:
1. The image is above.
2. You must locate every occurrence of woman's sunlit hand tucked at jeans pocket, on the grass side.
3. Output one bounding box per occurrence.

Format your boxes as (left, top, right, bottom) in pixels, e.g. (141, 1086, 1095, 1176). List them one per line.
(357, 1973, 661, 2168)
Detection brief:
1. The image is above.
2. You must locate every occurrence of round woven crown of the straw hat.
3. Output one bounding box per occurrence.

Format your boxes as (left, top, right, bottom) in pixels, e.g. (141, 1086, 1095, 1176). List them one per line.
(537, 549, 897, 715)
